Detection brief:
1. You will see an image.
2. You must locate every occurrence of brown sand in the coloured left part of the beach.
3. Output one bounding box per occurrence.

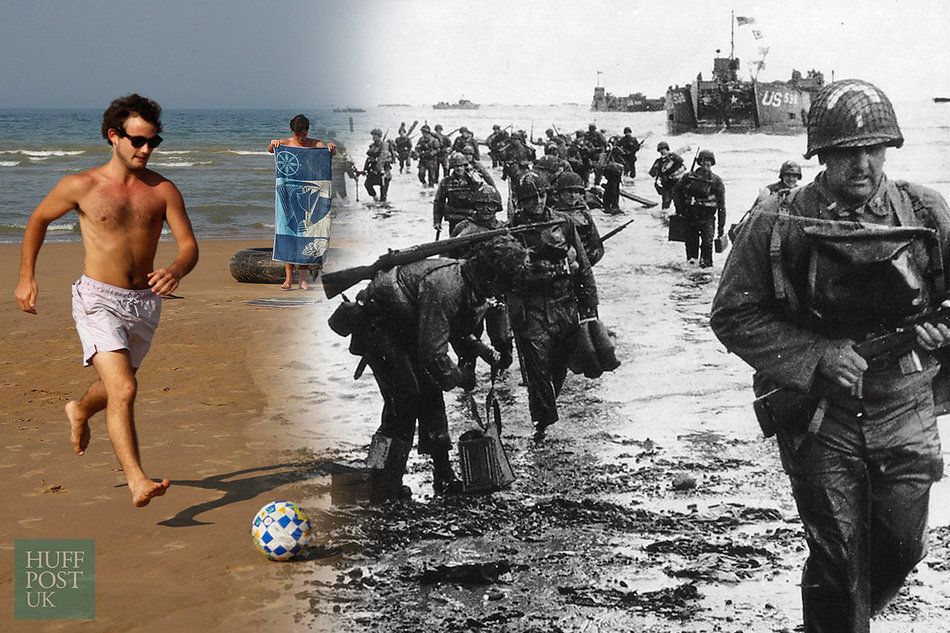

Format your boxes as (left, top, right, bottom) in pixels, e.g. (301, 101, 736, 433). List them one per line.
(0, 241, 342, 631)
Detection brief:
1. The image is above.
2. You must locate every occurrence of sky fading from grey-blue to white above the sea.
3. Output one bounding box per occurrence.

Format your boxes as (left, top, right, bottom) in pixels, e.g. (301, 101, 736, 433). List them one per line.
(0, 0, 950, 109)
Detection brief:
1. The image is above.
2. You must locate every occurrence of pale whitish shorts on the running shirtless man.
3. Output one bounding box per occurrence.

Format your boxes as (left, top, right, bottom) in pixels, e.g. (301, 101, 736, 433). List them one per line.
(73, 275, 162, 367)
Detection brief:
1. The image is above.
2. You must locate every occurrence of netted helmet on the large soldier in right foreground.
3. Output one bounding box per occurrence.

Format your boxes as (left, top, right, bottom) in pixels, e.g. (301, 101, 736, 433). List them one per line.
(805, 79, 904, 158)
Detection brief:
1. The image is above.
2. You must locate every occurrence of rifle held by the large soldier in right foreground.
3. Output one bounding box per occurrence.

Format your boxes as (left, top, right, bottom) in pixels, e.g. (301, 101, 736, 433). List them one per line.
(752, 306, 950, 437)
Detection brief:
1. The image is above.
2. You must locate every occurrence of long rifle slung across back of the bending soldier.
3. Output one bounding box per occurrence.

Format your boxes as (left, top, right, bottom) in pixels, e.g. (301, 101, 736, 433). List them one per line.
(320, 219, 565, 299)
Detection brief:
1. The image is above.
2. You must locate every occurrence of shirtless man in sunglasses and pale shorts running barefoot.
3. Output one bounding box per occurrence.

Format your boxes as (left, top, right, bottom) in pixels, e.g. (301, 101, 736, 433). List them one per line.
(15, 94, 198, 507)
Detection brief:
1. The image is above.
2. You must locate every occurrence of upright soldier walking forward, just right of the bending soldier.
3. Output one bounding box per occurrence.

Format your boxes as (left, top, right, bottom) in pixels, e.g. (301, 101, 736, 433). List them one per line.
(507, 178, 597, 440)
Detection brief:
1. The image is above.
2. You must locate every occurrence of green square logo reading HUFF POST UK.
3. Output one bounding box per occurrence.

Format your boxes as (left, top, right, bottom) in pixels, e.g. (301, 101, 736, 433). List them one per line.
(14, 539, 96, 620)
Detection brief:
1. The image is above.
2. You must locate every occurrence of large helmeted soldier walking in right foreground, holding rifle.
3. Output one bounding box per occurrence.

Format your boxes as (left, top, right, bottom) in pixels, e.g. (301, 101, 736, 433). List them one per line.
(711, 80, 950, 633)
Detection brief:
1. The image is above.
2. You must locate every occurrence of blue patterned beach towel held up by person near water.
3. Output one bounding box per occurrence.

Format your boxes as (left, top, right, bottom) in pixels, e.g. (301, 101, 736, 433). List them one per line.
(274, 145, 333, 265)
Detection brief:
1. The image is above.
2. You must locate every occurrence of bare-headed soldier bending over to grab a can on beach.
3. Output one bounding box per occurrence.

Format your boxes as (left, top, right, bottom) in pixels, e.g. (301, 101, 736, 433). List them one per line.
(358, 237, 526, 498)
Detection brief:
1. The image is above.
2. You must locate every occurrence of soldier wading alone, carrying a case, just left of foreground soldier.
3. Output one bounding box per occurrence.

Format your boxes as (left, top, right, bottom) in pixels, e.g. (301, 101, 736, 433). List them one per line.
(673, 149, 726, 268)
